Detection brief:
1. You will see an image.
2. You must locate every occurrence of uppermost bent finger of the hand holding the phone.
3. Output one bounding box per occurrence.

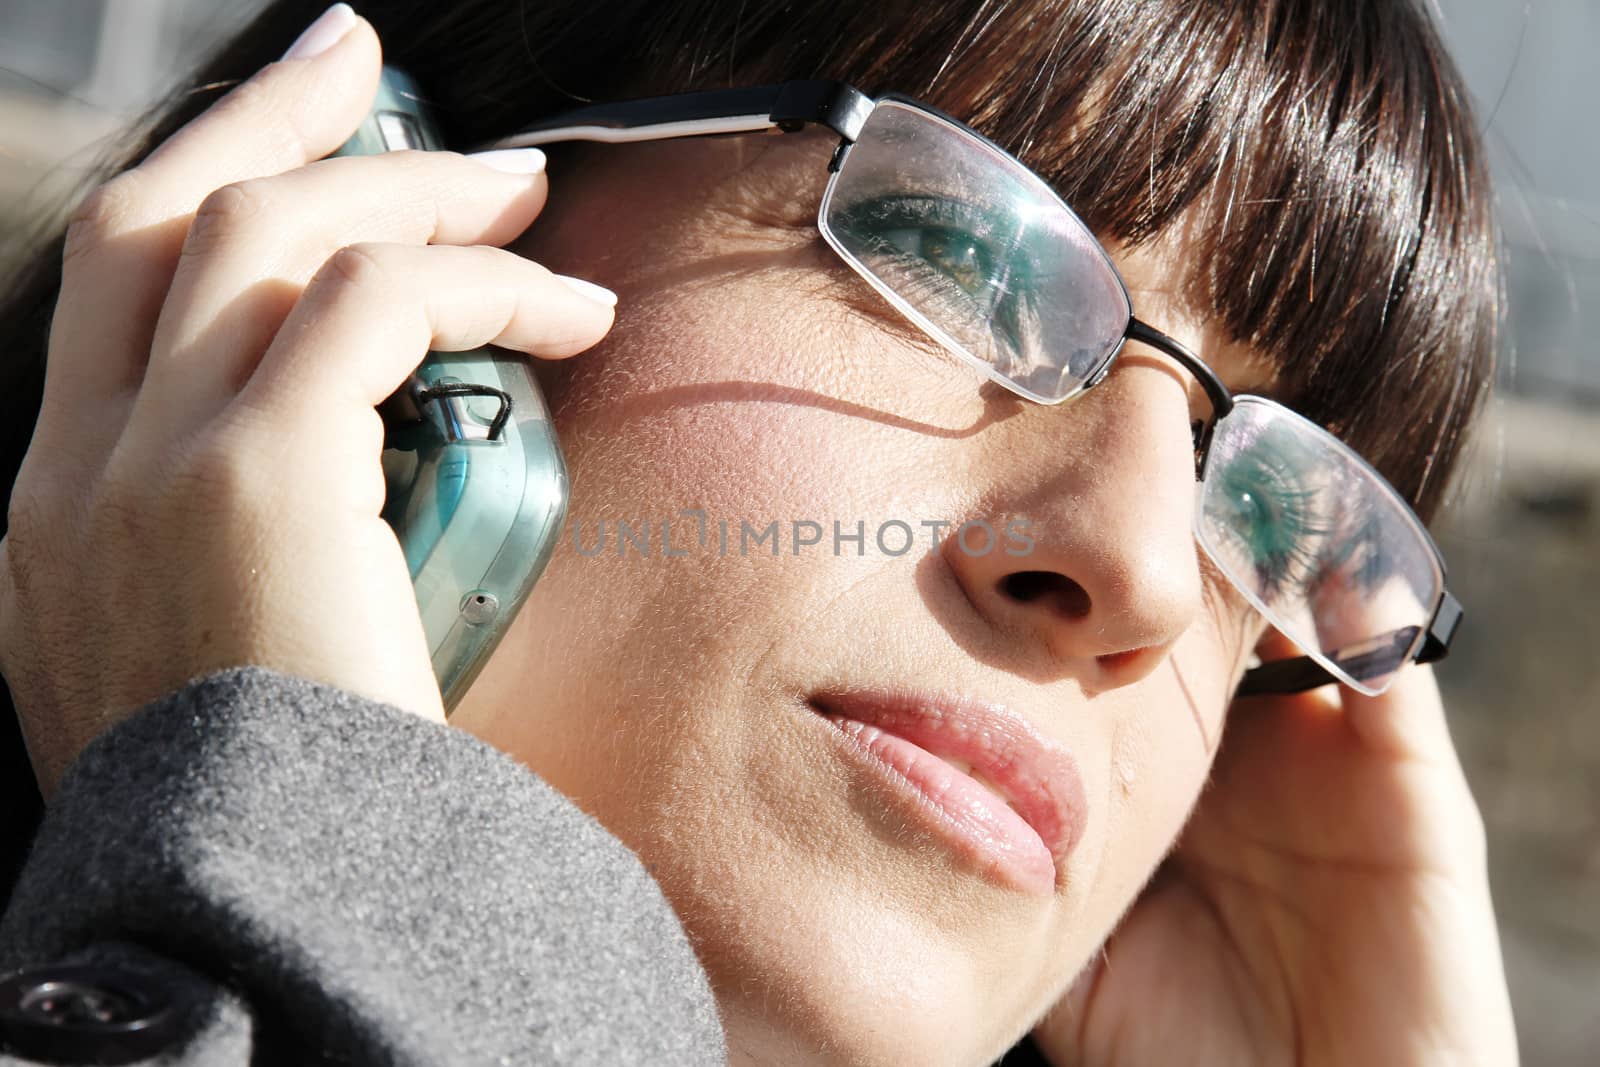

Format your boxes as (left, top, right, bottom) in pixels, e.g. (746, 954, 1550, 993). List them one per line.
(40, 5, 382, 432)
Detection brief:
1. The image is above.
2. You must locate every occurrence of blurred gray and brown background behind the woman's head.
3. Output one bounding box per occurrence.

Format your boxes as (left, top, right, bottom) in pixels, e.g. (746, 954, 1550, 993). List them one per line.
(0, 0, 1600, 1067)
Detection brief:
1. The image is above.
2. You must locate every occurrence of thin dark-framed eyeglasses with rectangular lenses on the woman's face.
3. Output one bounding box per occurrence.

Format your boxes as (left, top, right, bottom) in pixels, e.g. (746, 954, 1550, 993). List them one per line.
(488, 82, 1462, 694)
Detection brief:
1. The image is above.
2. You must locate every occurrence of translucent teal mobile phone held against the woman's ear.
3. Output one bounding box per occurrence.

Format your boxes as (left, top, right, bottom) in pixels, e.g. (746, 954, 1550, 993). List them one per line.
(334, 67, 566, 712)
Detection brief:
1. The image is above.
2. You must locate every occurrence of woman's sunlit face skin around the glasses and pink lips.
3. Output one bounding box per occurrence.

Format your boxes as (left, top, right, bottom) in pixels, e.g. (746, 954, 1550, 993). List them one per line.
(453, 127, 1259, 1064)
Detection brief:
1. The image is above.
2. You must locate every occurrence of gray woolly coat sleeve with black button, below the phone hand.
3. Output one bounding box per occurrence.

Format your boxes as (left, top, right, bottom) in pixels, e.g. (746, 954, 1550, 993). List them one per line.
(0, 667, 725, 1067)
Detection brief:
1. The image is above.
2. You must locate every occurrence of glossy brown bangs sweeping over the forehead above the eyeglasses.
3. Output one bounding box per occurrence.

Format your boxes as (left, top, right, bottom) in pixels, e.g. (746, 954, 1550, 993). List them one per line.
(678, 0, 1499, 518)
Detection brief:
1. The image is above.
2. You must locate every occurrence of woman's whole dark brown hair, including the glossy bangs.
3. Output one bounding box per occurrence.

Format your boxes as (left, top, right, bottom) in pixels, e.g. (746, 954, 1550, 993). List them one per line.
(0, 0, 1498, 895)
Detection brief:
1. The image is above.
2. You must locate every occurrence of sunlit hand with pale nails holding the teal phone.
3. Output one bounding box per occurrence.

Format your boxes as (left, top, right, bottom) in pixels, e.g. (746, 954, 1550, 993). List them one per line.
(0, 12, 613, 797)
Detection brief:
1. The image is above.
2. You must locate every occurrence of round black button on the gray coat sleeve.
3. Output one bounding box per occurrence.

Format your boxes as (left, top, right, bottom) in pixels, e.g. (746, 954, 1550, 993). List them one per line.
(0, 965, 184, 1065)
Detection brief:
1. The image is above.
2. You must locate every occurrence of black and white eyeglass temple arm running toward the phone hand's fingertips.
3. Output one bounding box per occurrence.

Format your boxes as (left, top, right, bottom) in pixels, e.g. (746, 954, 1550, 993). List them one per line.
(483, 82, 872, 149)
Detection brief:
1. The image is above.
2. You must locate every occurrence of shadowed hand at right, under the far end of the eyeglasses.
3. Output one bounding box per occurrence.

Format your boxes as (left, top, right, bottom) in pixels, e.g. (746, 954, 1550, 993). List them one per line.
(1035, 653, 1517, 1067)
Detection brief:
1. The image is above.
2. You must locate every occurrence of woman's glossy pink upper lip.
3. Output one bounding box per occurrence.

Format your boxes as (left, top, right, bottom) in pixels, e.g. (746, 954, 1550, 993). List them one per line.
(811, 689, 1085, 861)
